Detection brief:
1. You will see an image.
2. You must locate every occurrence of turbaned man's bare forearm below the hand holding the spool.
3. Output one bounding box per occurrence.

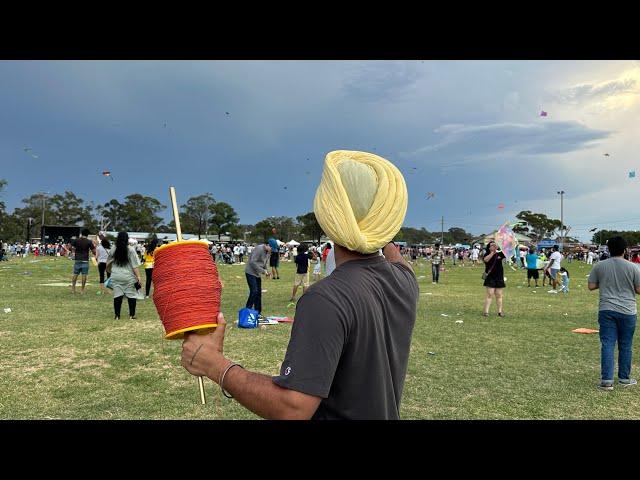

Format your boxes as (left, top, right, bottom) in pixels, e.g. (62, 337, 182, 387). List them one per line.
(209, 358, 308, 420)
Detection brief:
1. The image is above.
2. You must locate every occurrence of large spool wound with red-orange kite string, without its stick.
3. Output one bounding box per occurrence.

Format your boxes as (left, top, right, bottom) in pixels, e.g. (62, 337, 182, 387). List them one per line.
(153, 240, 221, 339)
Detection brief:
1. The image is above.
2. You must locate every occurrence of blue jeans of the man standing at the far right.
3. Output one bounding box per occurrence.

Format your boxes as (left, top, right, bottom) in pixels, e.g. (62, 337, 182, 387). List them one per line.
(598, 310, 637, 383)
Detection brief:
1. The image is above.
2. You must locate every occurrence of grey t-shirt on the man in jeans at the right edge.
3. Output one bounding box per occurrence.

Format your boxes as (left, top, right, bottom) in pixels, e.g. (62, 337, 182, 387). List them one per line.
(589, 257, 640, 315)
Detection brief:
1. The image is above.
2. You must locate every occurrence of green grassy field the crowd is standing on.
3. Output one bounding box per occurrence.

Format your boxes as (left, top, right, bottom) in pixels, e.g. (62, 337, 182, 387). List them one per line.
(0, 253, 640, 419)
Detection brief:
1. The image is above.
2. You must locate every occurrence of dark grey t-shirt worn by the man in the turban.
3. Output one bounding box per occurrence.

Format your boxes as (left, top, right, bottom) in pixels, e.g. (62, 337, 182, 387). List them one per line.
(273, 256, 419, 420)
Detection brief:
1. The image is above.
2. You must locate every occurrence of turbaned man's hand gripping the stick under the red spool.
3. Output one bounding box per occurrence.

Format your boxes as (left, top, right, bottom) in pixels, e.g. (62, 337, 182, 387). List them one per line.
(182, 313, 227, 382)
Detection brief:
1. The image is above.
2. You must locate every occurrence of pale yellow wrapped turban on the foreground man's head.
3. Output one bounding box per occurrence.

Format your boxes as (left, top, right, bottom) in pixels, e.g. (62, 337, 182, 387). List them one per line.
(313, 150, 407, 253)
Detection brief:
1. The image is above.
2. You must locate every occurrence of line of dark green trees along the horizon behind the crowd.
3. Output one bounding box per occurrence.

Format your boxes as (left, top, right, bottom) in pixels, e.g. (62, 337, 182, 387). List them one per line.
(0, 179, 640, 248)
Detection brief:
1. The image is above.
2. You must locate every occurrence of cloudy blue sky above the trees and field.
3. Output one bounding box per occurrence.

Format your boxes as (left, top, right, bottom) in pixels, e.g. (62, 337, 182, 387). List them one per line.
(0, 60, 640, 239)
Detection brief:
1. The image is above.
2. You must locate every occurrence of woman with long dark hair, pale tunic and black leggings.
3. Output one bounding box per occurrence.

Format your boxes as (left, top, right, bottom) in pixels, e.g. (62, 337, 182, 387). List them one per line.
(107, 232, 142, 320)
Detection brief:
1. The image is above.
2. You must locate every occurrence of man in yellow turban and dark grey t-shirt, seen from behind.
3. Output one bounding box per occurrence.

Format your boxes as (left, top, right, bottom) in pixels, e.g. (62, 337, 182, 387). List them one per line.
(182, 150, 419, 420)
